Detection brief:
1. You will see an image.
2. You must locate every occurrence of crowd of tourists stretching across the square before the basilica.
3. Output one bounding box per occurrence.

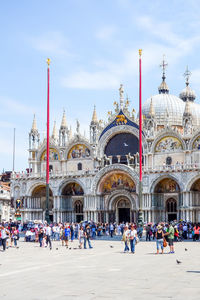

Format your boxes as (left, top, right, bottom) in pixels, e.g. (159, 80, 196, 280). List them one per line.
(0, 221, 200, 254)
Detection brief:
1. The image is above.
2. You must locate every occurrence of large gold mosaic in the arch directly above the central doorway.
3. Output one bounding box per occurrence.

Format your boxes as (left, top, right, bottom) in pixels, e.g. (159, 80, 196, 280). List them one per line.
(100, 172, 136, 193)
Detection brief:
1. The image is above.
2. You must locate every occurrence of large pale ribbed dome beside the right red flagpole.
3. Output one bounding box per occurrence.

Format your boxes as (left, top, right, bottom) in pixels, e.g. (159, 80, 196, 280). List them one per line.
(142, 94, 185, 125)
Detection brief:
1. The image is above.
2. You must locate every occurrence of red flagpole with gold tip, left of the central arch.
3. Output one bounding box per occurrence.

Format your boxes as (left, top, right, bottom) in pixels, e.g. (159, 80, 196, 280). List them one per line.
(45, 58, 51, 222)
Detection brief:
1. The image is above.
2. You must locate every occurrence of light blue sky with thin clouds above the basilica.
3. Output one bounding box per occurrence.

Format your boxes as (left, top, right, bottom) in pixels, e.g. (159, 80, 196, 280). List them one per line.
(0, 0, 200, 172)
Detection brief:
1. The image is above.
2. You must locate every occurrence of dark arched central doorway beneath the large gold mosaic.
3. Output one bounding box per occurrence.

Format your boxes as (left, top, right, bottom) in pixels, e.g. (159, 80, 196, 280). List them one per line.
(116, 198, 131, 223)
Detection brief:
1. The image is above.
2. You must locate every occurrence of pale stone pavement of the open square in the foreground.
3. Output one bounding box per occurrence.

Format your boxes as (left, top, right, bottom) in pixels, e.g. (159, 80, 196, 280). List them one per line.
(0, 240, 200, 300)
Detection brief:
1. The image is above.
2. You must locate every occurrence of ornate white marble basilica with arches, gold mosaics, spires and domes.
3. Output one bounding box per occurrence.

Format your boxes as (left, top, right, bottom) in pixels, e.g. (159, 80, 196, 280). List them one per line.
(11, 62, 200, 222)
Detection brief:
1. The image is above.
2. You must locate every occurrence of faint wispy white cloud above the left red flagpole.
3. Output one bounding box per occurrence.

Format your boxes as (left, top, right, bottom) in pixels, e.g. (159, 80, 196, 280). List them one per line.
(29, 31, 69, 55)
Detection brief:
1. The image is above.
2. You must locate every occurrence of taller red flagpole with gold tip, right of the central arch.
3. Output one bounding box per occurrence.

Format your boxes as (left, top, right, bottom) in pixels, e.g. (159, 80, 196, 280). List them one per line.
(138, 49, 143, 224)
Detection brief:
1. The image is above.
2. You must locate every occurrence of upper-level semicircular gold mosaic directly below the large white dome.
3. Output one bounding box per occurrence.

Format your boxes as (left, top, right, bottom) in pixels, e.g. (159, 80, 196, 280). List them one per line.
(155, 136, 183, 153)
